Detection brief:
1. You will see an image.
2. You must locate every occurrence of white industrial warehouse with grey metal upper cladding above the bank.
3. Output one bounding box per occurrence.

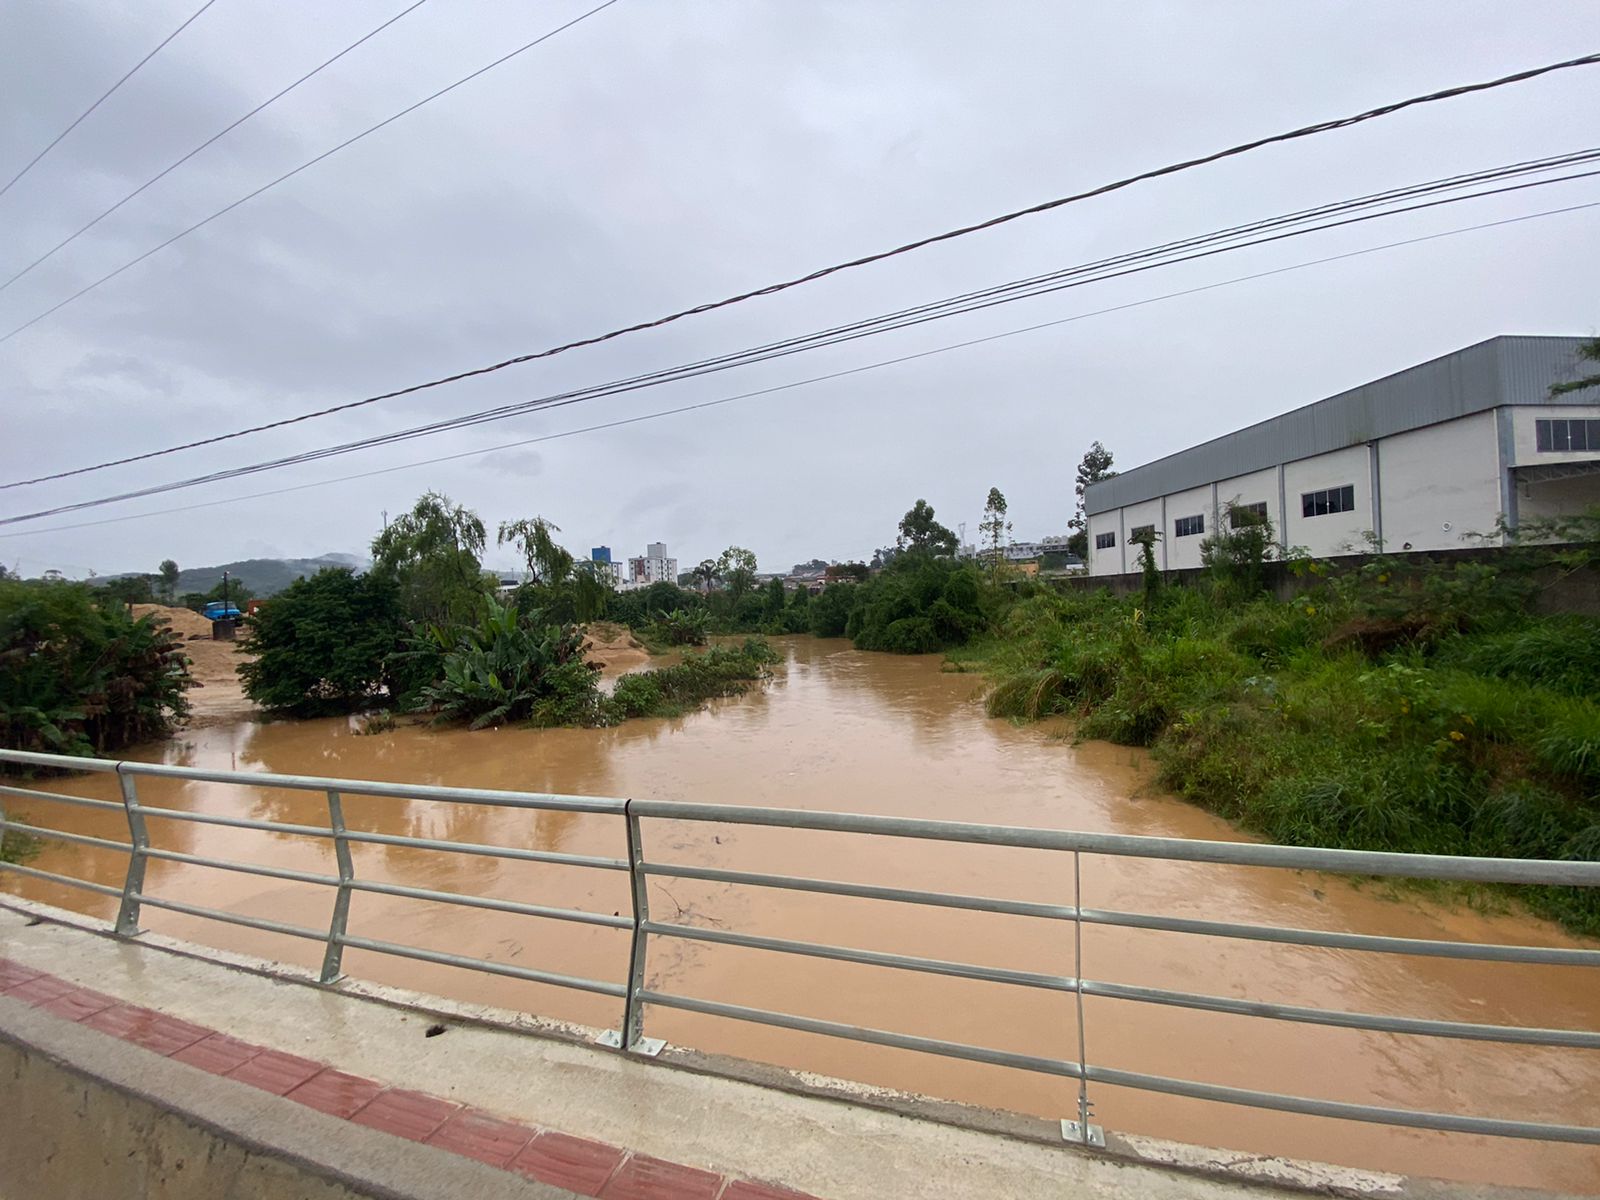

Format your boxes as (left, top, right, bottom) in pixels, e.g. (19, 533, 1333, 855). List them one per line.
(1083, 336, 1600, 574)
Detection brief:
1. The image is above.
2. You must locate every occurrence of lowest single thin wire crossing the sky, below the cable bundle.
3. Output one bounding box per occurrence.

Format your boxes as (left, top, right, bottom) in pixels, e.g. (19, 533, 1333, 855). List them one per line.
(0, 200, 1600, 538)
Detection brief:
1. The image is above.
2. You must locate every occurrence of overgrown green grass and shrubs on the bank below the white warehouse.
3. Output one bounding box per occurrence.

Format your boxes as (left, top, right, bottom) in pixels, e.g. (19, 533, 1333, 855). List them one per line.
(960, 518, 1600, 934)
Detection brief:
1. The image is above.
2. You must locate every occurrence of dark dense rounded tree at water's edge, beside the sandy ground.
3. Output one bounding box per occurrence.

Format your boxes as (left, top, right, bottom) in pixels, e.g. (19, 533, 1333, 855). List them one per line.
(238, 566, 405, 717)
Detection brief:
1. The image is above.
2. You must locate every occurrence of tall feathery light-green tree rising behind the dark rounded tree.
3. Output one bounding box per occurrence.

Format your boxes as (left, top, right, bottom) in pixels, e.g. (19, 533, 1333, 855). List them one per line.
(373, 491, 488, 624)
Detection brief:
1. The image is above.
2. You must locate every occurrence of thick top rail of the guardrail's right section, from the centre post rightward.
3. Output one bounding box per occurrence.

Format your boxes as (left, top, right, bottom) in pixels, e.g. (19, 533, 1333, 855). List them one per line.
(629, 800, 1600, 886)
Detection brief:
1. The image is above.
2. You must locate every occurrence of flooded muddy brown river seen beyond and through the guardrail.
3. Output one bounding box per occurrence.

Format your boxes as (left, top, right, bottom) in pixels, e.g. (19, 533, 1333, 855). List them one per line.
(3, 638, 1600, 1192)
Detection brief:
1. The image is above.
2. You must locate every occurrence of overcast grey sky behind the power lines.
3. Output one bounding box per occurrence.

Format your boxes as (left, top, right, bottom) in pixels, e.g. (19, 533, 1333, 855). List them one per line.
(0, 0, 1600, 576)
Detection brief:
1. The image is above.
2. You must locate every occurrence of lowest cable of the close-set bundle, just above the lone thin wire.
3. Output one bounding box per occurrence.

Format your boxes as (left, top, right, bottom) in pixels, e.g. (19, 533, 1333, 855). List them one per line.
(0, 170, 1600, 525)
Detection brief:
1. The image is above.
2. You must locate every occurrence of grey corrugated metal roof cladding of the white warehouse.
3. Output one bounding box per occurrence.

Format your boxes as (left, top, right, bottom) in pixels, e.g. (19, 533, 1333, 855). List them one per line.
(1083, 334, 1595, 514)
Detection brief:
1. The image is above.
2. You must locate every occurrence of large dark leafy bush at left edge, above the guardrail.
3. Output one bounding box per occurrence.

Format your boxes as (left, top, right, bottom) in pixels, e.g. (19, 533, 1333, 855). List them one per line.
(0, 581, 189, 755)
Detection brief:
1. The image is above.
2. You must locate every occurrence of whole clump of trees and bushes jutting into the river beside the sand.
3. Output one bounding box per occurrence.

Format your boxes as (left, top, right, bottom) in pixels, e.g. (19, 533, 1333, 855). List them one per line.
(240, 493, 776, 730)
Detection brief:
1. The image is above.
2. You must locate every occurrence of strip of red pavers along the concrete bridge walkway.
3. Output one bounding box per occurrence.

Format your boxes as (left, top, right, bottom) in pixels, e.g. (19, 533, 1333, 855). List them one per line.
(0, 958, 813, 1200)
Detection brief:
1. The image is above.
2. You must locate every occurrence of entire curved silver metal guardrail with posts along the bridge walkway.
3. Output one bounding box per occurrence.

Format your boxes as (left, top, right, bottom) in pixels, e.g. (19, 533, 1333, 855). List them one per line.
(0, 750, 1600, 1146)
